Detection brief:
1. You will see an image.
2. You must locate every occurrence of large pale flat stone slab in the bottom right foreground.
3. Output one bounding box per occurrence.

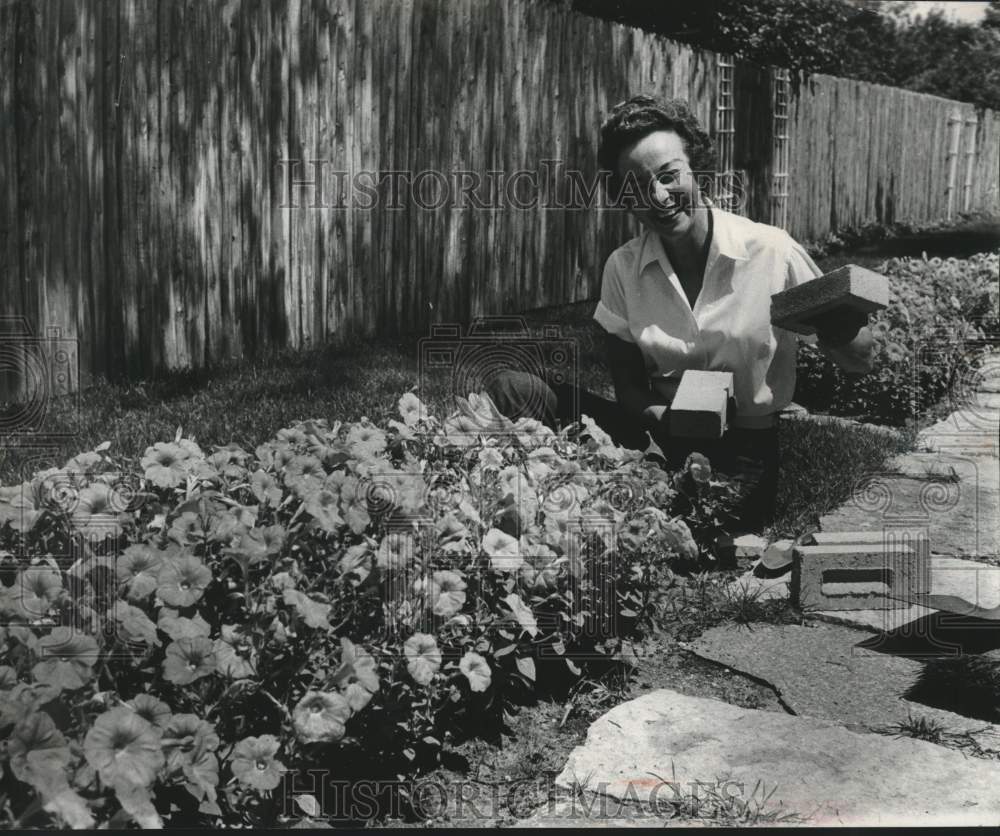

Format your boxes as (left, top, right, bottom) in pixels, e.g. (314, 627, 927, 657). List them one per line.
(556, 689, 1000, 826)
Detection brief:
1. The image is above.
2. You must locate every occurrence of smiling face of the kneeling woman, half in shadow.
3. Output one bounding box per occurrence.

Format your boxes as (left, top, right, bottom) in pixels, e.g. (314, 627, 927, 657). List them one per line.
(618, 131, 704, 238)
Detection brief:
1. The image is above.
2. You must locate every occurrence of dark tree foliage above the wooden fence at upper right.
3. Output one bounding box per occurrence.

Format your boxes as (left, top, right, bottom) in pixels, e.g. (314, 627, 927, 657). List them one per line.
(568, 0, 1000, 109)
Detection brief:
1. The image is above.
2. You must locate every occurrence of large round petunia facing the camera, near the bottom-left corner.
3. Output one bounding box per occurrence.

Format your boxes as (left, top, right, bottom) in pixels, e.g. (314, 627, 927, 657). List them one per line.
(83, 706, 164, 787)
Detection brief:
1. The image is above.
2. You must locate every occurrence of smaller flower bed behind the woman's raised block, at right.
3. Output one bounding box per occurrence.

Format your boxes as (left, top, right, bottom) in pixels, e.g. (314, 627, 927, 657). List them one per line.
(796, 253, 1000, 425)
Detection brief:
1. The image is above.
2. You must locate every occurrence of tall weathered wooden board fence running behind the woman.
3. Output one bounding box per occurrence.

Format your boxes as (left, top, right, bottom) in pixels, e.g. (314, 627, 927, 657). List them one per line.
(0, 0, 1000, 396)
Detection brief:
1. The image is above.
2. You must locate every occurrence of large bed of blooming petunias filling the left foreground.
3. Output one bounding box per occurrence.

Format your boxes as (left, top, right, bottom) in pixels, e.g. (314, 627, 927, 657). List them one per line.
(0, 394, 740, 827)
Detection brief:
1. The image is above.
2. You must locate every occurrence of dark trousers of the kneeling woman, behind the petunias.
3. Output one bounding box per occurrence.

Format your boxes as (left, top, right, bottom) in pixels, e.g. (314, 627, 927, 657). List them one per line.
(486, 371, 778, 530)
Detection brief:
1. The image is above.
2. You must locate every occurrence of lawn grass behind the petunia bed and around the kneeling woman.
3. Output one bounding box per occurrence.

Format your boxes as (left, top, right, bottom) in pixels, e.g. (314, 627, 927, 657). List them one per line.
(0, 302, 898, 535)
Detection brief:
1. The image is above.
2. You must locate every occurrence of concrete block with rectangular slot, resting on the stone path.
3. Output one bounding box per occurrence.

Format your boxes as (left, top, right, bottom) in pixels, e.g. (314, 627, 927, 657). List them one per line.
(791, 531, 930, 611)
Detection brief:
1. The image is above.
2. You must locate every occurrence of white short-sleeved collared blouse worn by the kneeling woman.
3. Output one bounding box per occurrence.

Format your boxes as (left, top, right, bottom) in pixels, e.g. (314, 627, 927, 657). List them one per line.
(594, 208, 822, 426)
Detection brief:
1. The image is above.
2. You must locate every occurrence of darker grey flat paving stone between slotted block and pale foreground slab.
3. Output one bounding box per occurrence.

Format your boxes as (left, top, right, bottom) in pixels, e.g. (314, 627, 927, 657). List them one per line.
(688, 622, 1000, 732)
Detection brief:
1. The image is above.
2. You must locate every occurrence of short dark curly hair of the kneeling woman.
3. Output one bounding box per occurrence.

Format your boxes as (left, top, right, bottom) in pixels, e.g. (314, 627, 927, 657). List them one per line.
(597, 95, 716, 179)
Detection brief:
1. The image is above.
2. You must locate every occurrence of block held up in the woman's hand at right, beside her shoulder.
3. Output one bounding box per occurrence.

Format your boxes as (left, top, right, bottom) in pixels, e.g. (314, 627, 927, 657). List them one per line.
(771, 264, 889, 334)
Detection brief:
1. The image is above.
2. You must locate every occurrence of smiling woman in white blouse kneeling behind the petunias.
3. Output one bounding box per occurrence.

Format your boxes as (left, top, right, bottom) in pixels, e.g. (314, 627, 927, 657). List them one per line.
(489, 96, 873, 525)
